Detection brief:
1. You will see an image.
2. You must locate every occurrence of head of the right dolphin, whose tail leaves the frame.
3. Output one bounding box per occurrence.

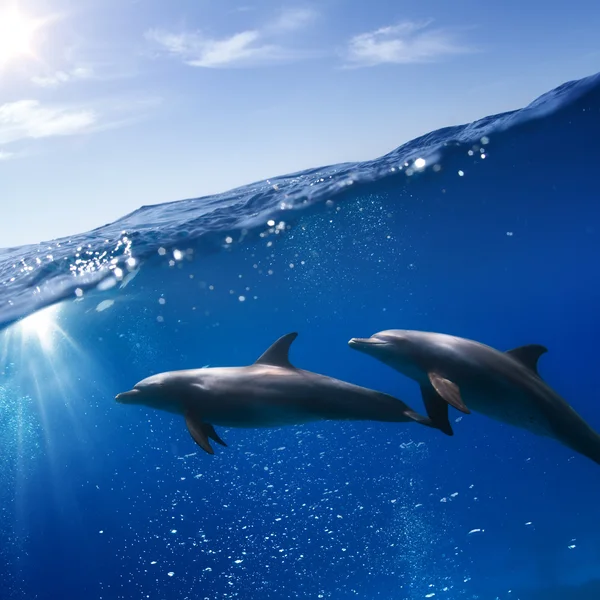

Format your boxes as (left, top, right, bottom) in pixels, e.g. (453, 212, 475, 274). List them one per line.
(348, 329, 431, 380)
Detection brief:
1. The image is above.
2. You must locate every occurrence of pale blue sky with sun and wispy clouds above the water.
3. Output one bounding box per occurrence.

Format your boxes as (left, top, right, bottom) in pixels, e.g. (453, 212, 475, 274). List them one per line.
(0, 0, 600, 247)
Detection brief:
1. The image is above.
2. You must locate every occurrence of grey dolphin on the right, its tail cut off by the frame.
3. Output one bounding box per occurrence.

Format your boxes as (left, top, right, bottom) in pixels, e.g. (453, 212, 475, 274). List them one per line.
(348, 329, 600, 464)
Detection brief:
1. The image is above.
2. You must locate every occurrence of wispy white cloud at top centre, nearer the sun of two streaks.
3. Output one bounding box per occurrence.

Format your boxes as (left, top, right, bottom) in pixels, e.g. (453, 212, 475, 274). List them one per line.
(145, 9, 315, 68)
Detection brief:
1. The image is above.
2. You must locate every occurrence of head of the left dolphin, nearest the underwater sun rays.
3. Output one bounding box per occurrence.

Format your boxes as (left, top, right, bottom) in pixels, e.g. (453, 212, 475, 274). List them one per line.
(115, 373, 195, 413)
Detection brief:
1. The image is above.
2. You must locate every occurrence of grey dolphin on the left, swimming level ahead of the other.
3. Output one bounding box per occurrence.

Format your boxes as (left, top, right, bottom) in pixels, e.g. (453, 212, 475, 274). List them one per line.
(116, 333, 434, 454)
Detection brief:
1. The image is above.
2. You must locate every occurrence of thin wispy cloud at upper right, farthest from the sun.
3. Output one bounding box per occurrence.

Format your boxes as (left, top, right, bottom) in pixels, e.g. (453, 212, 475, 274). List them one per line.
(345, 21, 472, 67)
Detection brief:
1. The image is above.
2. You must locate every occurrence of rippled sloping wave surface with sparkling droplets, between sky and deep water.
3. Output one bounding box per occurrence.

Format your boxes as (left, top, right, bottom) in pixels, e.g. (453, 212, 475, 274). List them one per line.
(0, 74, 600, 328)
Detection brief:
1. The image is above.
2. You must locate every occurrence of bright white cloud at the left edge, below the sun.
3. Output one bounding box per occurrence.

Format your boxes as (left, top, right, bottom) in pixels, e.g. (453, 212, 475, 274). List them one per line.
(0, 100, 98, 144)
